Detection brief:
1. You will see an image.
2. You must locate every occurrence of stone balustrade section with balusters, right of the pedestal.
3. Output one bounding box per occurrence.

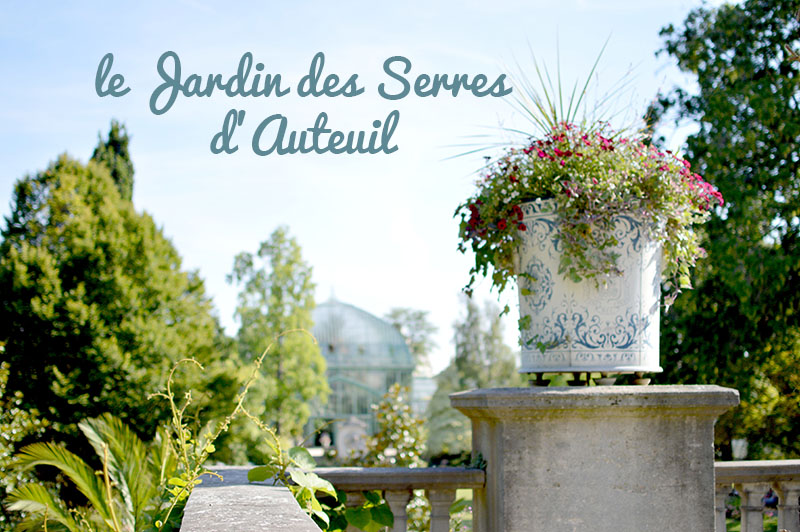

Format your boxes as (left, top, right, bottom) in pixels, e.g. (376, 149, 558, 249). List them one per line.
(714, 460, 800, 532)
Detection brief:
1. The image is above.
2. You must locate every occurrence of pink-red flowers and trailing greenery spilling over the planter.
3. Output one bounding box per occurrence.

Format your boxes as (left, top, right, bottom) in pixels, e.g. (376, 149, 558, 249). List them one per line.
(455, 121, 723, 304)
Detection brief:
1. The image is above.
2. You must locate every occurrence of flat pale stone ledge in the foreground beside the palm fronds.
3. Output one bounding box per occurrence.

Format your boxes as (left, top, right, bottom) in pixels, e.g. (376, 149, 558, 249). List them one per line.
(181, 466, 320, 532)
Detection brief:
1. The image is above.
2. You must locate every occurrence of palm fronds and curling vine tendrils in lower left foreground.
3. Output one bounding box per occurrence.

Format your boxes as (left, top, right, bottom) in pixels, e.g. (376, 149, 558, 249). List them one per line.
(9, 331, 324, 532)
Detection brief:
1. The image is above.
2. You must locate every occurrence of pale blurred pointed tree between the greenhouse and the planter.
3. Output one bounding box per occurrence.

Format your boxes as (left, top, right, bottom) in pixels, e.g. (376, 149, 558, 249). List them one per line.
(427, 296, 524, 457)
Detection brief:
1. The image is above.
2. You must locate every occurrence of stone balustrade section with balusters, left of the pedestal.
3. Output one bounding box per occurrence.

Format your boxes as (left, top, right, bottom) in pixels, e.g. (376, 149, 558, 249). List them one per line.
(315, 467, 486, 532)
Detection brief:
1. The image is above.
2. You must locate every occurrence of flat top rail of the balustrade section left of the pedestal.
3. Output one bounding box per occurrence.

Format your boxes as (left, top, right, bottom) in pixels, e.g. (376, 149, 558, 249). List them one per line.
(314, 467, 486, 491)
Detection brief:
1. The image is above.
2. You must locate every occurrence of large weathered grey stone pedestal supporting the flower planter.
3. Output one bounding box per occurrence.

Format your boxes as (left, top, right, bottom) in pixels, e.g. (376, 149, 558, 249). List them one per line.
(450, 386, 739, 532)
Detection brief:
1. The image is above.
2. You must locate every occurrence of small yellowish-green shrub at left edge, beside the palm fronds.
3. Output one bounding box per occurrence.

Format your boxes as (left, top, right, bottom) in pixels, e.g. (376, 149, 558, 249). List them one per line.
(0, 343, 43, 531)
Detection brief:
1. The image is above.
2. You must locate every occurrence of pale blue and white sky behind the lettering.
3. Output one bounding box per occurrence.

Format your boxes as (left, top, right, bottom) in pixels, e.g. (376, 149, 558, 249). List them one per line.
(0, 0, 712, 371)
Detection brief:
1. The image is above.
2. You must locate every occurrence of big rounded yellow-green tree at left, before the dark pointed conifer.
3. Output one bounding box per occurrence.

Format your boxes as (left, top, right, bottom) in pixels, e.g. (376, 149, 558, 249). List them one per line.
(0, 156, 235, 444)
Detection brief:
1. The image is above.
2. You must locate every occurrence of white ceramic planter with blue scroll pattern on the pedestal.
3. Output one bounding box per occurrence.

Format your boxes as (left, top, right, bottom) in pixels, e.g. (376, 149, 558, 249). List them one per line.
(517, 200, 662, 373)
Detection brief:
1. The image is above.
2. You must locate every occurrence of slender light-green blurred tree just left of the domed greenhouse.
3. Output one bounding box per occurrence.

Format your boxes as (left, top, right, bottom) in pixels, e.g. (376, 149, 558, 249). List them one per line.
(228, 227, 329, 437)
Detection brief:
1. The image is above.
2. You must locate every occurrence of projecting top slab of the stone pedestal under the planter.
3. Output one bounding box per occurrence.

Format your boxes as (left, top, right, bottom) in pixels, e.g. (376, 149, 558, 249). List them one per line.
(450, 385, 739, 418)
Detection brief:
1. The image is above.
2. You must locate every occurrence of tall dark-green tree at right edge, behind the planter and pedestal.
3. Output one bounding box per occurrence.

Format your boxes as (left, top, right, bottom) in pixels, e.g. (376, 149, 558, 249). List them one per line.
(660, 0, 800, 458)
